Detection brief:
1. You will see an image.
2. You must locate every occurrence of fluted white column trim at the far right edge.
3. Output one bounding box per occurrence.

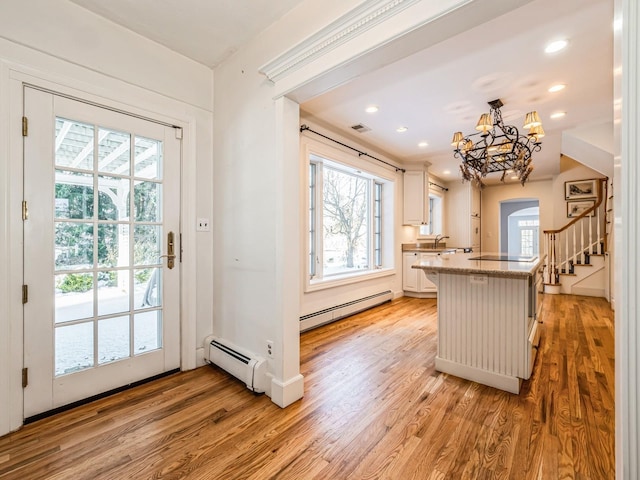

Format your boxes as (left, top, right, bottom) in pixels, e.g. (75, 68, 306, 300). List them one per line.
(614, 0, 640, 480)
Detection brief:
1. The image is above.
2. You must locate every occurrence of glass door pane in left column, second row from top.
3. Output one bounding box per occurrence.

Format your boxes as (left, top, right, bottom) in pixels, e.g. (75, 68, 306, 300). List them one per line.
(55, 170, 93, 220)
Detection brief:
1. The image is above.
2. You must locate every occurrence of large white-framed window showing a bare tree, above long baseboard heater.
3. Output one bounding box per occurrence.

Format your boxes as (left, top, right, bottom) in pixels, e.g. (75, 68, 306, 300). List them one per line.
(308, 154, 392, 283)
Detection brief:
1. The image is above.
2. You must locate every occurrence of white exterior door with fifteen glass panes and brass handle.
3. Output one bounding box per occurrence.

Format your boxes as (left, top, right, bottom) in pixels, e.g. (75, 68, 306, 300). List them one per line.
(23, 87, 180, 418)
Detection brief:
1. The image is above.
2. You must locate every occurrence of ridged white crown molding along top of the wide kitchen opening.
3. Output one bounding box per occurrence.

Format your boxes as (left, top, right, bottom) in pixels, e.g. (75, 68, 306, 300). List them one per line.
(259, 0, 421, 82)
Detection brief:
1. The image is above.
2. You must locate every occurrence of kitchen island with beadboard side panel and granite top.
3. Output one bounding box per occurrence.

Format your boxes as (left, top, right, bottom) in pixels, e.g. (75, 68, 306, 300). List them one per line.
(412, 253, 544, 394)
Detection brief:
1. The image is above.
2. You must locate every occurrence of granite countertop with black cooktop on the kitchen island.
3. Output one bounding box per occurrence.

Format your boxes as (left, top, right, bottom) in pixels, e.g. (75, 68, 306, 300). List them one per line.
(412, 252, 545, 277)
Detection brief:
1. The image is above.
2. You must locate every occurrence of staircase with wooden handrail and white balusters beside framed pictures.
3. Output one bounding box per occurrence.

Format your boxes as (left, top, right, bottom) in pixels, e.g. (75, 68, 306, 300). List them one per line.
(543, 178, 613, 298)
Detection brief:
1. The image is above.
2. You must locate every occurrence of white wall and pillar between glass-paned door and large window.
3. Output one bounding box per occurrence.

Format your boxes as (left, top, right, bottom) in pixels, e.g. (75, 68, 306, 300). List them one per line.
(213, 0, 368, 406)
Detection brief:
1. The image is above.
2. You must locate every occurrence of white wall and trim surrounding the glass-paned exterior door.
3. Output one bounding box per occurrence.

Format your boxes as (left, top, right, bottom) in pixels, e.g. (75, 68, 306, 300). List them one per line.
(0, 0, 213, 434)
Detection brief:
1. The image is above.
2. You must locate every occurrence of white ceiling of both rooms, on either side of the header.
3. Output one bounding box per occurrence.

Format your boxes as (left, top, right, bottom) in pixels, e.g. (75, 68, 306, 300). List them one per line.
(71, 0, 614, 183)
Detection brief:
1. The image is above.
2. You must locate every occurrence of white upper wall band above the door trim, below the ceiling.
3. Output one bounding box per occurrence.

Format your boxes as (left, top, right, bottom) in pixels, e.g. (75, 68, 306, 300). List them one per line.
(0, 0, 212, 110)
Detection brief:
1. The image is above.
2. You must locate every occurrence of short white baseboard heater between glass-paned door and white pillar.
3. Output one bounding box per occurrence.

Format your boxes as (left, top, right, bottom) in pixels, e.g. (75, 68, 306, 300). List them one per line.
(204, 335, 268, 393)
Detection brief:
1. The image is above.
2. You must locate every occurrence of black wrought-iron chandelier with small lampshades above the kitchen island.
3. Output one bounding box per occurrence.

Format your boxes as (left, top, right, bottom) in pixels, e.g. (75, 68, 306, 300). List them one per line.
(451, 99, 544, 188)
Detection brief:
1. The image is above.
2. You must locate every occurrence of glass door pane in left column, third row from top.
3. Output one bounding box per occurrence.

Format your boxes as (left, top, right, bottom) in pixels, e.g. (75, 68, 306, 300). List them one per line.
(54, 222, 93, 270)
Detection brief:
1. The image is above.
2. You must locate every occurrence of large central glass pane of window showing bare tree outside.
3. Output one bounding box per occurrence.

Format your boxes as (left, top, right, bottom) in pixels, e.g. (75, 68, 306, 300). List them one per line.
(323, 167, 370, 273)
